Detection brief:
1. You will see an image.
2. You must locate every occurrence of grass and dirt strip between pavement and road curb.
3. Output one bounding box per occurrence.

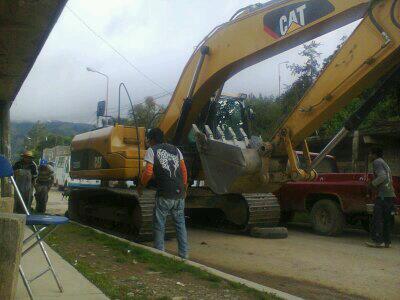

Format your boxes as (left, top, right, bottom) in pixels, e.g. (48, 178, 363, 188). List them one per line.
(47, 224, 278, 299)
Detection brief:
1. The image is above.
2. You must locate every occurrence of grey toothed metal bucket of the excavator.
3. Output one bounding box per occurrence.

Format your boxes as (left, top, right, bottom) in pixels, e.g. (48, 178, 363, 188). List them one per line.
(193, 125, 270, 194)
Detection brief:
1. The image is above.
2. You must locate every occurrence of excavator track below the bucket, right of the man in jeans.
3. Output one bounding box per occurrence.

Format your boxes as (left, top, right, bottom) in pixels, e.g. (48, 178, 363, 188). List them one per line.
(186, 187, 280, 233)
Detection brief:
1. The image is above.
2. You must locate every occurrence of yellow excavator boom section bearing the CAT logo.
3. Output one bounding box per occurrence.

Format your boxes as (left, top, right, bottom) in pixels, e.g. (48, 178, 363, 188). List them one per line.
(160, 0, 369, 142)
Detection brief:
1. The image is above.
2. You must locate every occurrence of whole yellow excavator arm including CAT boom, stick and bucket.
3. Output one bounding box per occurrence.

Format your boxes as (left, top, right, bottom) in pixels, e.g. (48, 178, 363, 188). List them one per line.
(170, 0, 400, 194)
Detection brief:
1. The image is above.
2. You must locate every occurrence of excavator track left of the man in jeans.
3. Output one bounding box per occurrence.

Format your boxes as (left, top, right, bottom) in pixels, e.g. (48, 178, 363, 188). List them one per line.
(68, 187, 175, 242)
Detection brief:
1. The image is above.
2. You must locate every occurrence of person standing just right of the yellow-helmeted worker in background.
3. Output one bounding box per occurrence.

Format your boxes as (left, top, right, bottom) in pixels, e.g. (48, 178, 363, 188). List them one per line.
(35, 159, 54, 214)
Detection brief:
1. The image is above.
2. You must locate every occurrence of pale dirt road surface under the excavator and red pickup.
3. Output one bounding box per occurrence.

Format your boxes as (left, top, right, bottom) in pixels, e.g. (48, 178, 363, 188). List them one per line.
(48, 191, 400, 299)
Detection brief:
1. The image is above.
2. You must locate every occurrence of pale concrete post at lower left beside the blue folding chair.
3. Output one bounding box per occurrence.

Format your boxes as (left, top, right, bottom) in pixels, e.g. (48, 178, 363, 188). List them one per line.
(0, 213, 25, 300)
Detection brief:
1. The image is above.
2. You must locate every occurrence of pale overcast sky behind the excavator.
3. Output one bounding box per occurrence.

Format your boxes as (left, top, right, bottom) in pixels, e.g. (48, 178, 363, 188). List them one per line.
(11, 0, 355, 123)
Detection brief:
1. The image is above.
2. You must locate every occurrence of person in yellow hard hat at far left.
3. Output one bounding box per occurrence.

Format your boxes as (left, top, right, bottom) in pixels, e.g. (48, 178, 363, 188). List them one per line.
(13, 150, 38, 214)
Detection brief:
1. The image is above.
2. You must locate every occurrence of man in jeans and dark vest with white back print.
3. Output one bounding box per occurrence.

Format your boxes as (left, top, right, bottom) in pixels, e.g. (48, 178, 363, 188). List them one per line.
(138, 128, 188, 259)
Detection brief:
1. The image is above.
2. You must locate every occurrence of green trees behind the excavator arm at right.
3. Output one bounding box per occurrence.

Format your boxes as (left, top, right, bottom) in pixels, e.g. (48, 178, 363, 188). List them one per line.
(248, 37, 400, 139)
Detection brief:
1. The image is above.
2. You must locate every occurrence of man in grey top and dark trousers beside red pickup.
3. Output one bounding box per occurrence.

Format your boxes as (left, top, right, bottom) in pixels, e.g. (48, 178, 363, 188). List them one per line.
(367, 147, 396, 248)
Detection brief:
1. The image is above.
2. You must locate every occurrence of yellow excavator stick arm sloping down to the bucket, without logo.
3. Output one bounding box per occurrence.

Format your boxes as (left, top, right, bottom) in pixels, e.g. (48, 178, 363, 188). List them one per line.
(272, 0, 400, 172)
